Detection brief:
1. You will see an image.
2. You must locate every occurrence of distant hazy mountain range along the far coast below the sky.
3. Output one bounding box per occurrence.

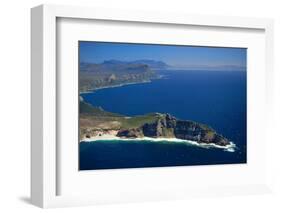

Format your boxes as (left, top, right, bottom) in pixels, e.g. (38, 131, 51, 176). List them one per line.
(79, 60, 166, 92)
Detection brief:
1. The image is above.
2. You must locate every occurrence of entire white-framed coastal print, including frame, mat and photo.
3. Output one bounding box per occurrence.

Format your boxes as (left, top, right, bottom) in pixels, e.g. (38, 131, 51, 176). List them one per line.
(31, 5, 273, 207)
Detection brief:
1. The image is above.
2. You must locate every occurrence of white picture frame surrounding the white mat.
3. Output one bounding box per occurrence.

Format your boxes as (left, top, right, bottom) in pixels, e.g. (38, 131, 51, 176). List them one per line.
(31, 5, 273, 208)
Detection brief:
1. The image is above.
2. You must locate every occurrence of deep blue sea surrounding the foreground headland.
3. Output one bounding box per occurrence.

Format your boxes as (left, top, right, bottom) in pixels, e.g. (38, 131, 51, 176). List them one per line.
(80, 71, 247, 170)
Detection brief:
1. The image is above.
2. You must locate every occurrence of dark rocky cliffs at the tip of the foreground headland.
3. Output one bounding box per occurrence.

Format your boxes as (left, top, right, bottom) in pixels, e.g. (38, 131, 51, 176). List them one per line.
(117, 114, 230, 146)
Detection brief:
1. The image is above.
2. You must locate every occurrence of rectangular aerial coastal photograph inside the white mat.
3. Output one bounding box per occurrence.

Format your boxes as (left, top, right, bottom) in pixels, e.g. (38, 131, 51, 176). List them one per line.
(78, 41, 247, 171)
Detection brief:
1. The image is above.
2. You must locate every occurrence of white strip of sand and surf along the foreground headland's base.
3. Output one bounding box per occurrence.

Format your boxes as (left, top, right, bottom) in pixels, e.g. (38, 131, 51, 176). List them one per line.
(80, 134, 236, 152)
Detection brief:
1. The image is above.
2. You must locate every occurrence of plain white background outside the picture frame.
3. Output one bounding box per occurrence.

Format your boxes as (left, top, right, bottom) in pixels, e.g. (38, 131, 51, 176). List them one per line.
(0, 0, 281, 213)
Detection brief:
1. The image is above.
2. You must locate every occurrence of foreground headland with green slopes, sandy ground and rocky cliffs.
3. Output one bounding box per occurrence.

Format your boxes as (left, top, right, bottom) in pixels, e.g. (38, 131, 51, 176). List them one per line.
(80, 101, 230, 146)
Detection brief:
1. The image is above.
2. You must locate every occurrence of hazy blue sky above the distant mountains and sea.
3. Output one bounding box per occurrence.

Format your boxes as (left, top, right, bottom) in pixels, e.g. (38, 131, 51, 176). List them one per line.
(79, 41, 247, 67)
